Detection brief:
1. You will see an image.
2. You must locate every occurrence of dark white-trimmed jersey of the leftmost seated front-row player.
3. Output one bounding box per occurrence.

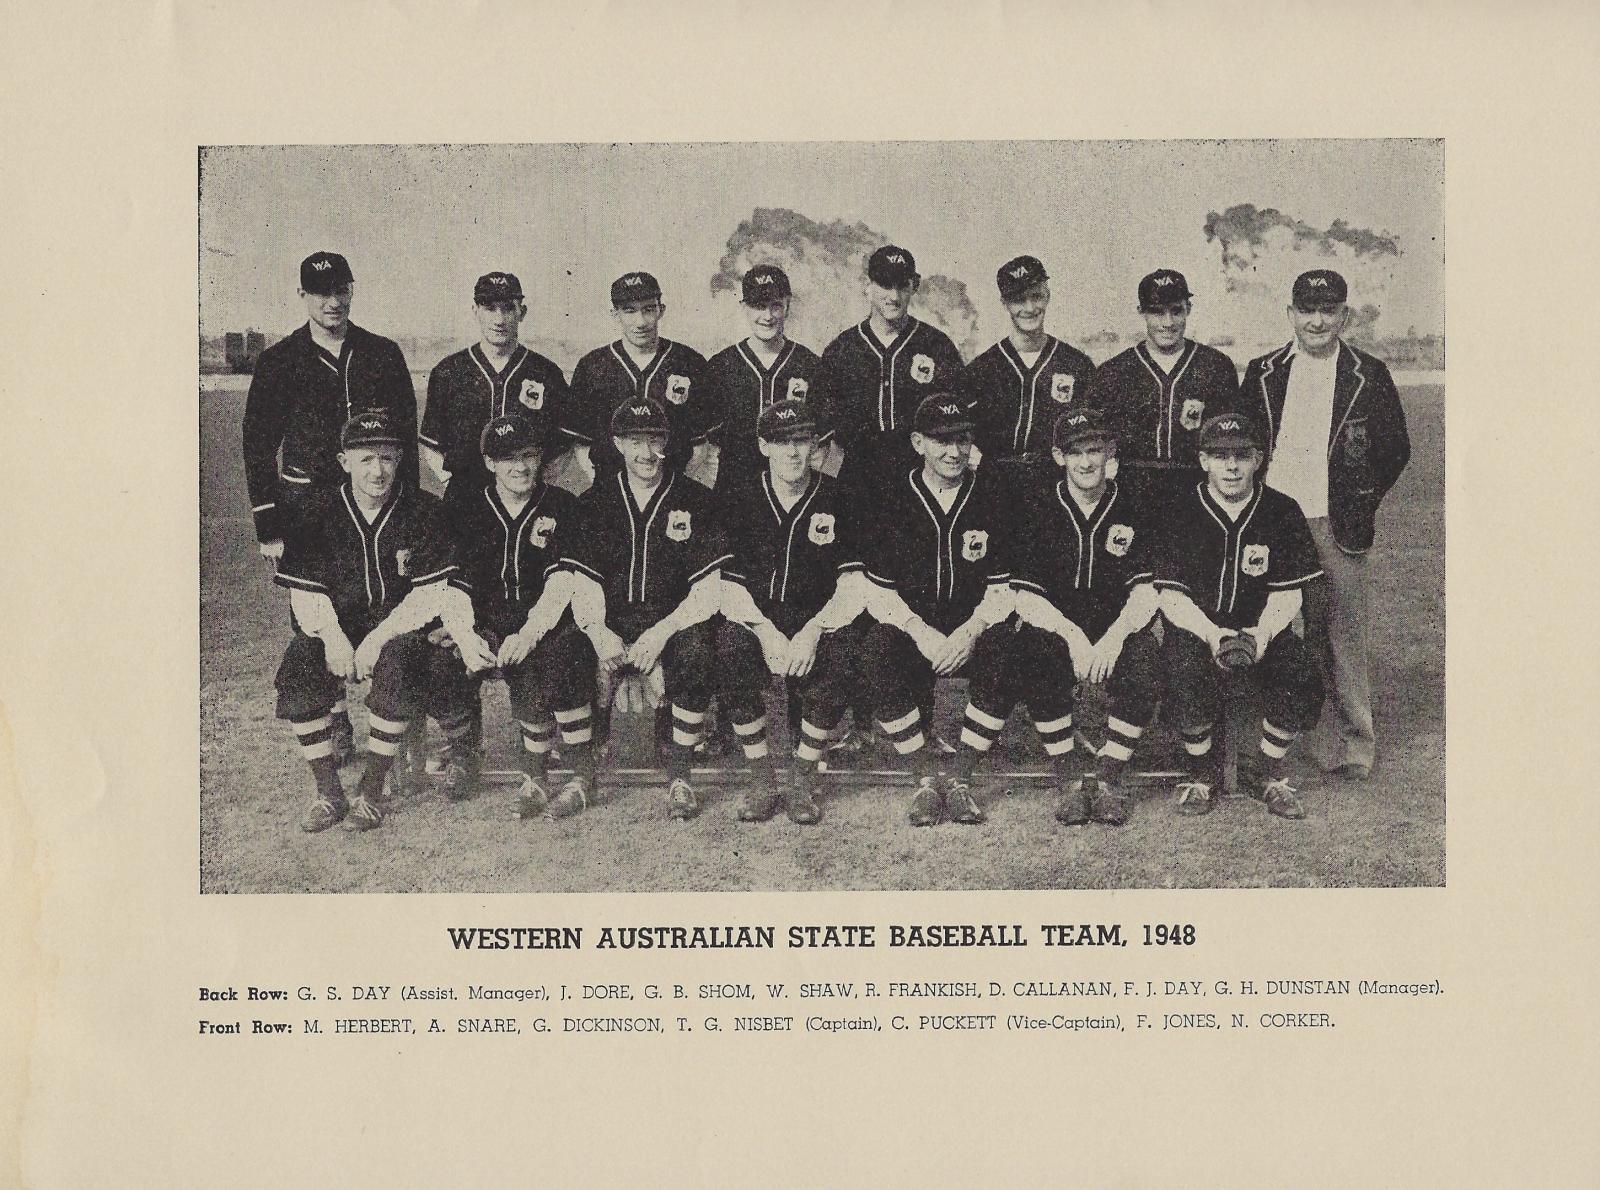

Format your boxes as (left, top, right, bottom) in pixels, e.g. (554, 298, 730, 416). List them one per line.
(274, 481, 458, 645)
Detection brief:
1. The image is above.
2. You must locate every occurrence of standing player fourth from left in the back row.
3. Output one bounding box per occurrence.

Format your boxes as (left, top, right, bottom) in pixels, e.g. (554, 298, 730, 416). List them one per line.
(706, 264, 818, 491)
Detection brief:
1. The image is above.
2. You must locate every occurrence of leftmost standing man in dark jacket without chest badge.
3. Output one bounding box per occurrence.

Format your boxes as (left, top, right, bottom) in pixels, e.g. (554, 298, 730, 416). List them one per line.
(245, 253, 418, 560)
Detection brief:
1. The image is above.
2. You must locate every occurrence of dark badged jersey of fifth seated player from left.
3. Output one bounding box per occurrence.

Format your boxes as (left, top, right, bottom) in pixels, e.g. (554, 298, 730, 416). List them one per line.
(862, 467, 1016, 632)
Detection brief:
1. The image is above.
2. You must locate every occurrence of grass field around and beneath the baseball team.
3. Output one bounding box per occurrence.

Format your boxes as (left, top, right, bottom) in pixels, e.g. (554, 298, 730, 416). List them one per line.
(198, 375, 1445, 893)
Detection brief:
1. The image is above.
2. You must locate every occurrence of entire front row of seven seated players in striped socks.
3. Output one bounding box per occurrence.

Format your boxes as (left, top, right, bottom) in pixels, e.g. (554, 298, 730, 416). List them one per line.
(277, 385, 1322, 830)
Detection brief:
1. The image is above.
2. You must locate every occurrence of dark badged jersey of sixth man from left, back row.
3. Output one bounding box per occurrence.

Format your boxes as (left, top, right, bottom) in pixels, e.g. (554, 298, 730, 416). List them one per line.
(960, 336, 1094, 459)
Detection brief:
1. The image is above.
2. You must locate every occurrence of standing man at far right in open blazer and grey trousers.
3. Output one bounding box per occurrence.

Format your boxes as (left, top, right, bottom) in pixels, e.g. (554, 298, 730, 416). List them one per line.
(1242, 269, 1411, 781)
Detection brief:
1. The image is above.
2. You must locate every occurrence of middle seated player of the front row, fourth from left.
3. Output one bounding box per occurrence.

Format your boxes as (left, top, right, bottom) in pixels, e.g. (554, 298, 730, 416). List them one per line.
(717, 400, 864, 824)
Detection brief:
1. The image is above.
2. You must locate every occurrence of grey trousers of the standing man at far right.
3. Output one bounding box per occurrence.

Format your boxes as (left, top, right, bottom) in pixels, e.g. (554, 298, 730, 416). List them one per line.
(1304, 517, 1378, 771)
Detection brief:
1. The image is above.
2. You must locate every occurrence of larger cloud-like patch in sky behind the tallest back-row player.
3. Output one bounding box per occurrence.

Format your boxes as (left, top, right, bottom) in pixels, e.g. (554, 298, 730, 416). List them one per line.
(710, 206, 982, 358)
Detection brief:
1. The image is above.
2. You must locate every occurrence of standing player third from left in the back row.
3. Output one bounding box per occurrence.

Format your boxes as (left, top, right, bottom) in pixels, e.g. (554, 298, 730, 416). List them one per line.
(558, 272, 718, 483)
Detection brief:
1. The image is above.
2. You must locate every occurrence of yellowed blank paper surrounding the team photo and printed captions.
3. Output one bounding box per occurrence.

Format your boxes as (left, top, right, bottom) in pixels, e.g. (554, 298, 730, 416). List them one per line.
(0, 3, 1600, 1187)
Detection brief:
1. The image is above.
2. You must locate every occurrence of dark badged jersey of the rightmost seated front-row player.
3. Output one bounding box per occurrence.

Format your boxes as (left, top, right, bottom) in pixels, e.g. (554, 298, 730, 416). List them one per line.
(1155, 481, 1322, 629)
